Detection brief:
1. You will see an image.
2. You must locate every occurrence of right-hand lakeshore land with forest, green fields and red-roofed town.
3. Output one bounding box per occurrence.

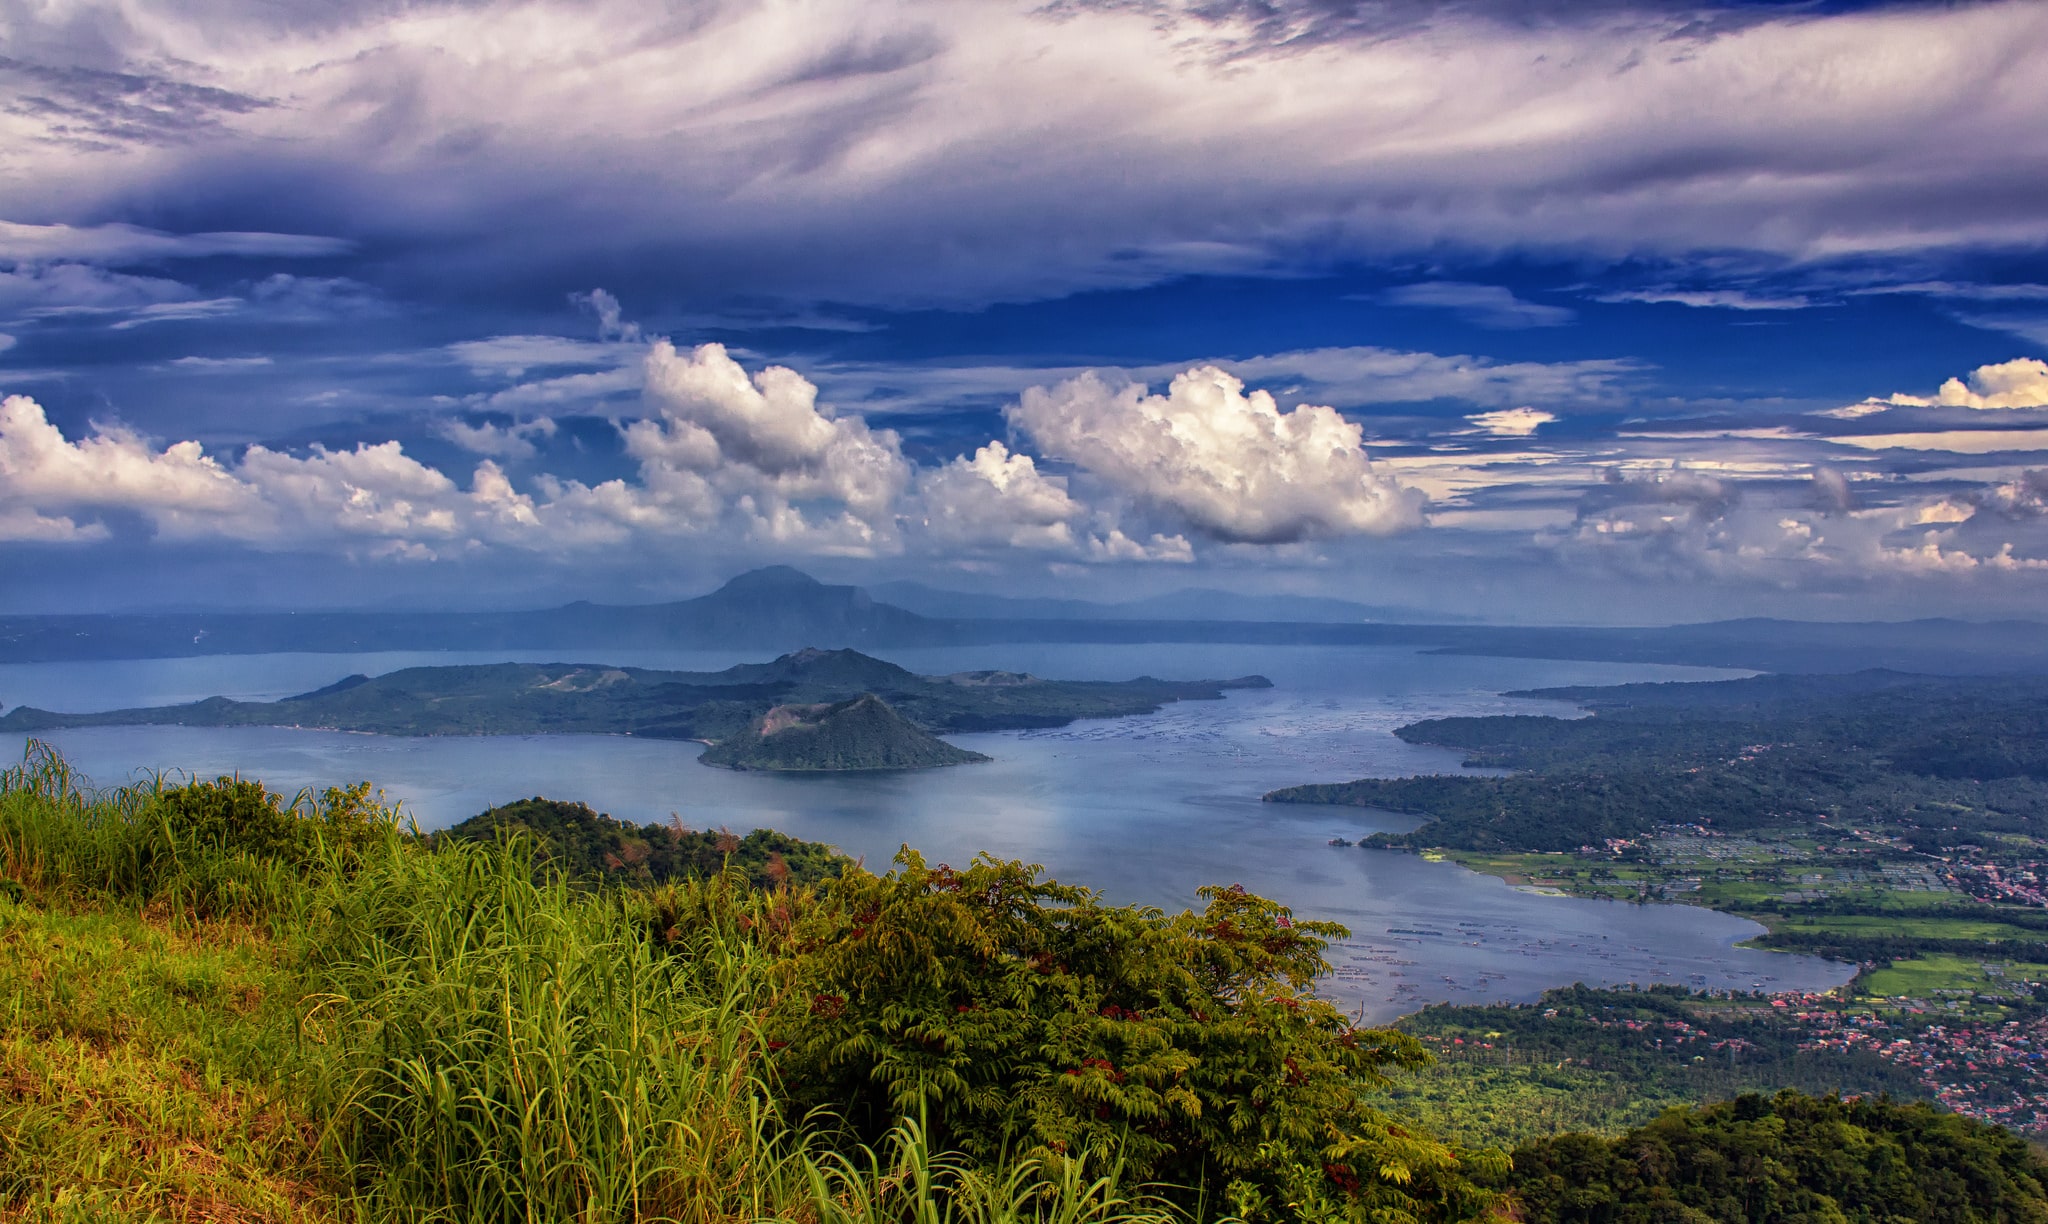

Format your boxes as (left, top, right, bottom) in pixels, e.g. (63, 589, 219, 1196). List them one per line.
(1268, 671, 2048, 1142)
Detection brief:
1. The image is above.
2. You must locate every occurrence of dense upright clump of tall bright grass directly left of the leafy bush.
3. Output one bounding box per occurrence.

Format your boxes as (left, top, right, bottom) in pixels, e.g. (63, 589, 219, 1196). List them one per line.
(303, 843, 801, 1220)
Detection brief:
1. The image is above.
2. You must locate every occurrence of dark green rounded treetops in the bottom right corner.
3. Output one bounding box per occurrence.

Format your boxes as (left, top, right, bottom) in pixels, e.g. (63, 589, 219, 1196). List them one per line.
(1507, 1093, 2048, 1224)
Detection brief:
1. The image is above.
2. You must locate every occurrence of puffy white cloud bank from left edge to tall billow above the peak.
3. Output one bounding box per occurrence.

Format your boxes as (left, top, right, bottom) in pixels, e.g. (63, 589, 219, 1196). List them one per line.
(0, 340, 921, 559)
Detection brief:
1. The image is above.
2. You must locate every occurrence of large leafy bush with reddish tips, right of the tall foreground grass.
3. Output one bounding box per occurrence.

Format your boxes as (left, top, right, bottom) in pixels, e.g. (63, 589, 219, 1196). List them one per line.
(770, 849, 1489, 1220)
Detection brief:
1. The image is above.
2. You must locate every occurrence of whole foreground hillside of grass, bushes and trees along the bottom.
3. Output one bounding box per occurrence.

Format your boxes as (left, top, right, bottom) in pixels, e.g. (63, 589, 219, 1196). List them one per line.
(0, 745, 2048, 1224)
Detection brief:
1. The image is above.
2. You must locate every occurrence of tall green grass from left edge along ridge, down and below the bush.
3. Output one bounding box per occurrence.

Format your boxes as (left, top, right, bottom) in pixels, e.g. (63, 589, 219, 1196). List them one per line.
(0, 745, 1196, 1224)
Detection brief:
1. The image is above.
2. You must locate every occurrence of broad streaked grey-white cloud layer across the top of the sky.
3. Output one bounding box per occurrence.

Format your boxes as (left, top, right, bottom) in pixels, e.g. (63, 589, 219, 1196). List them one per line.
(0, 0, 2048, 317)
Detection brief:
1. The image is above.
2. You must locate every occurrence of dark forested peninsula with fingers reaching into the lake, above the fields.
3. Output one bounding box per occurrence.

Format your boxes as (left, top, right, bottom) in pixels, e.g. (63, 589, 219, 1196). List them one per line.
(1268, 671, 2048, 851)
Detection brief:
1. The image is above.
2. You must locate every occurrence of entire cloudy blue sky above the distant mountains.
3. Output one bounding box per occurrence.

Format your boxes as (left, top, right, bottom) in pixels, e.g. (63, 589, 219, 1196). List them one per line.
(0, 0, 2048, 622)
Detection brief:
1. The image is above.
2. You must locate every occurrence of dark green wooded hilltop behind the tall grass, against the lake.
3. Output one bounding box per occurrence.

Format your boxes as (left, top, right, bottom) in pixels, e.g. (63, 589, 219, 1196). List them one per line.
(434, 796, 850, 888)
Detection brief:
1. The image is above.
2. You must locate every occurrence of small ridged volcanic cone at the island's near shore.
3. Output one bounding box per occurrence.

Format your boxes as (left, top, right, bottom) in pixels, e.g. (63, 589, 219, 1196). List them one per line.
(700, 692, 989, 774)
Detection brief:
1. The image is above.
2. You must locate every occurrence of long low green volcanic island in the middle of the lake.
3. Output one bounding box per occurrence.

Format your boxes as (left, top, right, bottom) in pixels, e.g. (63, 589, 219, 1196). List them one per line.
(0, 649, 1272, 772)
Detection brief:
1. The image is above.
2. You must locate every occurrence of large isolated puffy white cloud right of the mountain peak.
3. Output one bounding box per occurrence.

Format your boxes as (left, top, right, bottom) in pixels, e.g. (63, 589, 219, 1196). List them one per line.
(1008, 366, 1423, 544)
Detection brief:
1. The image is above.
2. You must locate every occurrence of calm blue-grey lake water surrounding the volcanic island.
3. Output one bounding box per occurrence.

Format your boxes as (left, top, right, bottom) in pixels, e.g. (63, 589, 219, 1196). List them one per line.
(0, 645, 1851, 1019)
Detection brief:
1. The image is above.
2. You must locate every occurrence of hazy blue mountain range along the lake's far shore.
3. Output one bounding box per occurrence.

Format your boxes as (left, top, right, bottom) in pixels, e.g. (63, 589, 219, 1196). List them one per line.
(0, 565, 2048, 679)
